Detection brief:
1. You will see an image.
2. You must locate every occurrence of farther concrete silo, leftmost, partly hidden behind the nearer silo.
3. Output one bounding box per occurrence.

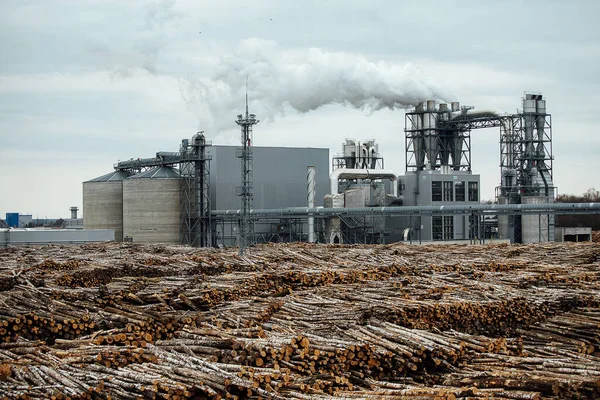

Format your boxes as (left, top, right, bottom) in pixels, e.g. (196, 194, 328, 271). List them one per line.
(83, 171, 130, 242)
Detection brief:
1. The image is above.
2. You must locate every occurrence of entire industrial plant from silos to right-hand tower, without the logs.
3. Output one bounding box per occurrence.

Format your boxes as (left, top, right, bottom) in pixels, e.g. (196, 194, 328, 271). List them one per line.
(78, 93, 596, 248)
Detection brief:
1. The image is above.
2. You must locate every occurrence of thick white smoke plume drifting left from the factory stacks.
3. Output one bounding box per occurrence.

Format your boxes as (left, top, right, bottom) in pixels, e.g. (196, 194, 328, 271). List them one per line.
(180, 38, 454, 131)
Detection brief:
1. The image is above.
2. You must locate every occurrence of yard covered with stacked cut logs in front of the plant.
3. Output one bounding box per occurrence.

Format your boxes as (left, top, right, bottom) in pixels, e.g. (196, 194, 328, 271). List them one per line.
(0, 243, 600, 400)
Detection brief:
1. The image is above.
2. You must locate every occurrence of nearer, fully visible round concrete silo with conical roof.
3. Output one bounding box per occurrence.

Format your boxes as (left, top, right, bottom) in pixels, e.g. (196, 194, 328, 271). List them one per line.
(123, 167, 181, 244)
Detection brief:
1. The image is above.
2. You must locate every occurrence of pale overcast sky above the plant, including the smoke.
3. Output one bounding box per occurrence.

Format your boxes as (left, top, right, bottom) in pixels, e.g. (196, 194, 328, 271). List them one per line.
(0, 0, 600, 217)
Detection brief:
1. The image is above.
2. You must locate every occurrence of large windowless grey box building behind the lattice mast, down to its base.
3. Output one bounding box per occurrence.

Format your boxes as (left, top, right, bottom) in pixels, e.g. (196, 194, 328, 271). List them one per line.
(207, 146, 329, 246)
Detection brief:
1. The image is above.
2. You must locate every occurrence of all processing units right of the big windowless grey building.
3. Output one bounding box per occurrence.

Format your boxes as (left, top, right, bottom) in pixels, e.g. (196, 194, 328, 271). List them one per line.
(326, 93, 555, 243)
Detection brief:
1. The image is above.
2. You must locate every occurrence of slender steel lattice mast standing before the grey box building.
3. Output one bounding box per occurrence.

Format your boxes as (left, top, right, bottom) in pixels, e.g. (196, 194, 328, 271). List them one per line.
(235, 91, 259, 255)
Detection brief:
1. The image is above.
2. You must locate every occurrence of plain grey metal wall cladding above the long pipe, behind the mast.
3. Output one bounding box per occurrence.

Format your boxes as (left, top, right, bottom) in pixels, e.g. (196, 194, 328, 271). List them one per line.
(207, 146, 329, 210)
